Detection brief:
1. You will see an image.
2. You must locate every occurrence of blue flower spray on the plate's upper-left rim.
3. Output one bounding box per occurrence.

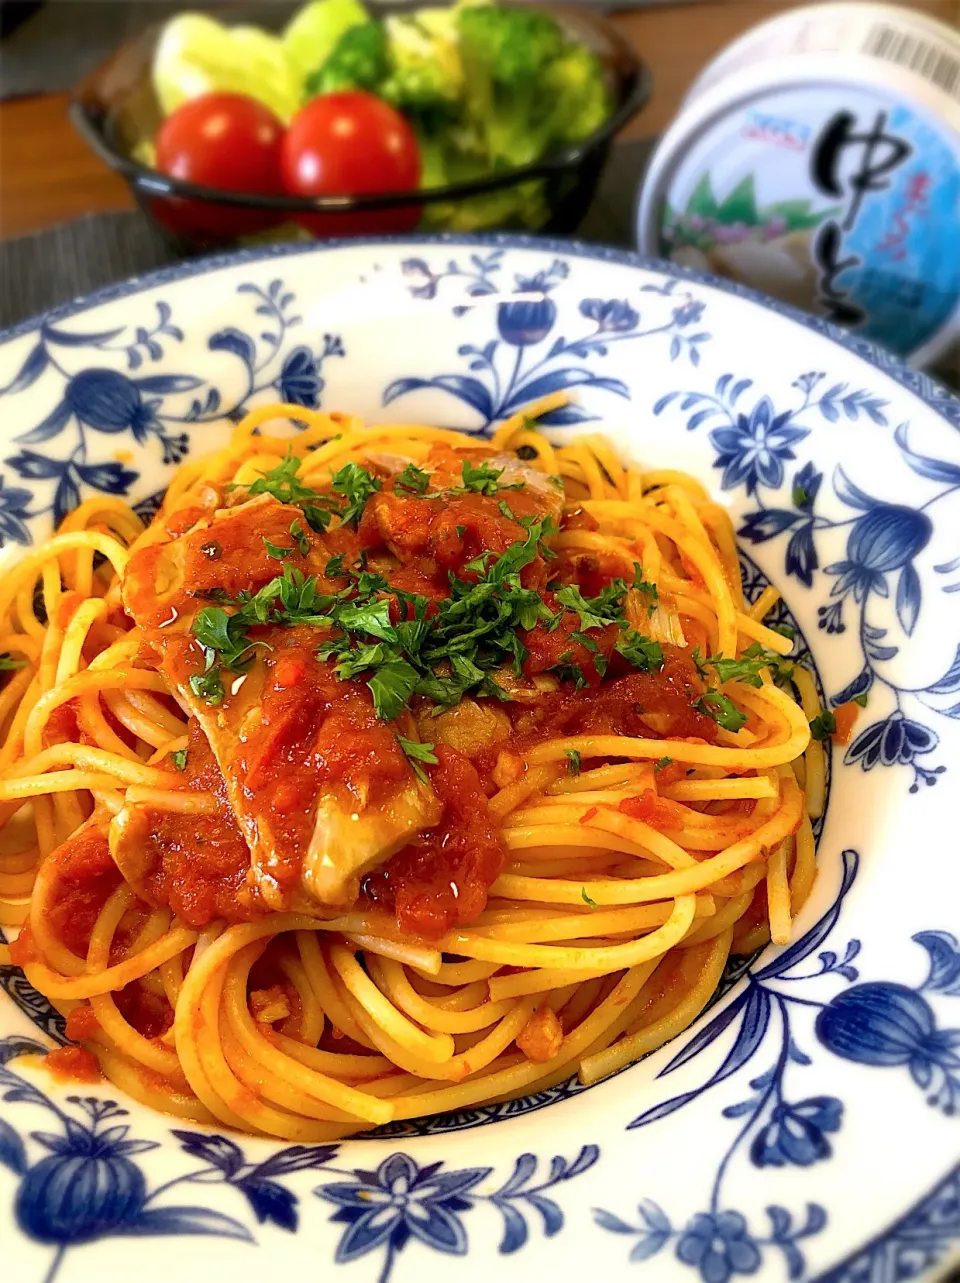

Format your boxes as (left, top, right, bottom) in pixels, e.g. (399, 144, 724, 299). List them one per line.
(0, 280, 345, 545)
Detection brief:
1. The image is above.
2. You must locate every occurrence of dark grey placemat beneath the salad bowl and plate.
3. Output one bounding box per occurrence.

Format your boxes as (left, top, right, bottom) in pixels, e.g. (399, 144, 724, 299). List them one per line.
(0, 141, 652, 327)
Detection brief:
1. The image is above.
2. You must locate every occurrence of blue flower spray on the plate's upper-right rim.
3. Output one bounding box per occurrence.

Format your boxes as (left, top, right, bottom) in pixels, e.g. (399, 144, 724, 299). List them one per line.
(653, 372, 960, 793)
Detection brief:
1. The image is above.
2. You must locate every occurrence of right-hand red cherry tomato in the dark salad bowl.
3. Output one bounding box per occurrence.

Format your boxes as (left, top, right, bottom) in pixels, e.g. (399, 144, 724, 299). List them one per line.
(281, 92, 420, 236)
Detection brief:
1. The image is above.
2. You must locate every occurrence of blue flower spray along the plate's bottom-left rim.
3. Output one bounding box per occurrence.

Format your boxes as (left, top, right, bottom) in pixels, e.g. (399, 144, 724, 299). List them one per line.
(0, 1037, 599, 1283)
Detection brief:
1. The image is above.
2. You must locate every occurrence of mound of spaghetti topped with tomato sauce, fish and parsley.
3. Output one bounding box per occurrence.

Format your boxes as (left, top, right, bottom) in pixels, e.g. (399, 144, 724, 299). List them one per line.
(0, 399, 824, 1142)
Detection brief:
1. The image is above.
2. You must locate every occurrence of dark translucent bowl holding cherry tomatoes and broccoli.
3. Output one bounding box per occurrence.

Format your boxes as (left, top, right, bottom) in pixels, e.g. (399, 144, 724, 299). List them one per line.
(71, 6, 651, 249)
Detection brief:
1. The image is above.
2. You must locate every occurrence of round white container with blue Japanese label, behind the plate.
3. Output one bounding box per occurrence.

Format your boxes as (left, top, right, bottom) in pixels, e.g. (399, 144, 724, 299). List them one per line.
(637, 4, 960, 384)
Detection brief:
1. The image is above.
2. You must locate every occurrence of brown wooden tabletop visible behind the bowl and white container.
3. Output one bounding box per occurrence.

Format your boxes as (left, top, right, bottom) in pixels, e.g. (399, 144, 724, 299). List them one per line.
(0, 0, 960, 236)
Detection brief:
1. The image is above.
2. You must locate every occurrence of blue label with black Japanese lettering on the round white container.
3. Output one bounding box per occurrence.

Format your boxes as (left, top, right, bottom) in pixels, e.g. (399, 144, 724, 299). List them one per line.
(660, 87, 960, 355)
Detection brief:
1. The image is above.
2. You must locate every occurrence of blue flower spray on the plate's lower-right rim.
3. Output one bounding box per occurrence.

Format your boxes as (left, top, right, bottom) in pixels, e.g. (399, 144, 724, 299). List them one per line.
(594, 851, 960, 1283)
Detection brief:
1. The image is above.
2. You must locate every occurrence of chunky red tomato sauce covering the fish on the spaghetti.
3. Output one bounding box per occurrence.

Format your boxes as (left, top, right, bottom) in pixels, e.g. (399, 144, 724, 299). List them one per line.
(105, 446, 716, 944)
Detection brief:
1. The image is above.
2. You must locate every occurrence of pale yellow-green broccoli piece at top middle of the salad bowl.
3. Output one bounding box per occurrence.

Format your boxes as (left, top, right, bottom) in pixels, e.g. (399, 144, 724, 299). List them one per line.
(380, 9, 463, 119)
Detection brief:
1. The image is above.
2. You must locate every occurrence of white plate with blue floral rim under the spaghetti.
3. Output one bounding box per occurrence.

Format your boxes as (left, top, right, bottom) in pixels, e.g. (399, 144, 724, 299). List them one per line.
(0, 239, 960, 1283)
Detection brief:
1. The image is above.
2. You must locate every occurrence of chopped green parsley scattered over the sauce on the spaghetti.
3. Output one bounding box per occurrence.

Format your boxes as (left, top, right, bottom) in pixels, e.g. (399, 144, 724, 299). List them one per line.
(183, 505, 664, 728)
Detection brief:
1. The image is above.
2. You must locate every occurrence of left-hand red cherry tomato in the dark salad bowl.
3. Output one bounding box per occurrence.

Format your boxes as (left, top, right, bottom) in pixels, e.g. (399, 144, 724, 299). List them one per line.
(153, 94, 284, 236)
